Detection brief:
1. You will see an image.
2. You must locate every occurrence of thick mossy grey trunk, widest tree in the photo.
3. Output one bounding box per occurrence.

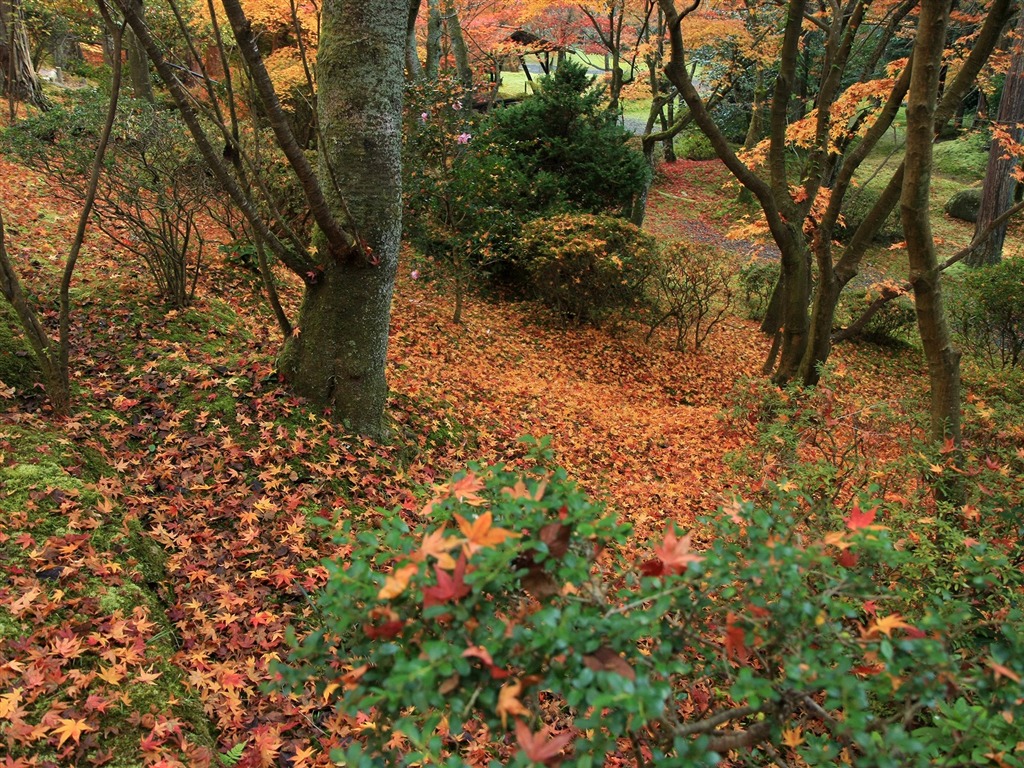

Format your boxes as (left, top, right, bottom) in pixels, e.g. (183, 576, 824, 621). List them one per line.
(280, 0, 409, 437)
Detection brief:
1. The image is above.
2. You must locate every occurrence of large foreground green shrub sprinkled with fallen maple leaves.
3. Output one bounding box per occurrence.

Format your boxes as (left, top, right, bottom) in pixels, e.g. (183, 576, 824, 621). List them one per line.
(281, 434, 1024, 768)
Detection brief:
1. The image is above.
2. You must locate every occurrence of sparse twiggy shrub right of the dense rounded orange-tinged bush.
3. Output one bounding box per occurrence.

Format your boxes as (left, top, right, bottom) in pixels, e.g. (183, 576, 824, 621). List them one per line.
(645, 241, 732, 350)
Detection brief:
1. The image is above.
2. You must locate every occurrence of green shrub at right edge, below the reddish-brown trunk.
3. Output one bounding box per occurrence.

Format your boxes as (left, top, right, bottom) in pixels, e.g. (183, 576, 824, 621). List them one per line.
(947, 258, 1024, 369)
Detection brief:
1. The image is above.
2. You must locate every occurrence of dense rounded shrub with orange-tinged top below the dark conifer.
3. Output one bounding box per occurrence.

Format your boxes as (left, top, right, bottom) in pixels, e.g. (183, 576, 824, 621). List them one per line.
(517, 214, 655, 325)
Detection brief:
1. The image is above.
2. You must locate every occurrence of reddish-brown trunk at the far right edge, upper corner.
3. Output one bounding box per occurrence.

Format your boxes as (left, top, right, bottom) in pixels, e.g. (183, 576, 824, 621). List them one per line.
(965, 8, 1024, 266)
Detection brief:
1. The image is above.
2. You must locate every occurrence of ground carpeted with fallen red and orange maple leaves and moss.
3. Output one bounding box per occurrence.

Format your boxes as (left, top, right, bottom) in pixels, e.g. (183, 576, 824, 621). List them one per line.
(0, 140, 1024, 767)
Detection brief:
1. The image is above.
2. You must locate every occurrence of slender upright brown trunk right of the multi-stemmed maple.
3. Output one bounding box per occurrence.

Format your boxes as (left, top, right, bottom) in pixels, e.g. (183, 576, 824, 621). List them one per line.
(900, 0, 961, 443)
